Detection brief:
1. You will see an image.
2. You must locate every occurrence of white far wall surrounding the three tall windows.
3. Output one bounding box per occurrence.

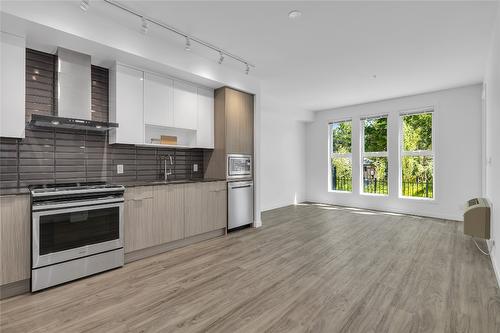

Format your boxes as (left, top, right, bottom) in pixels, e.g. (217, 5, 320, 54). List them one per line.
(306, 85, 482, 220)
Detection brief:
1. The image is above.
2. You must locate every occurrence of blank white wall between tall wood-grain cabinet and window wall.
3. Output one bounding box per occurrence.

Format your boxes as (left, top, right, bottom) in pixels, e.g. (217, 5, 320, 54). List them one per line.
(261, 112, 306, 211)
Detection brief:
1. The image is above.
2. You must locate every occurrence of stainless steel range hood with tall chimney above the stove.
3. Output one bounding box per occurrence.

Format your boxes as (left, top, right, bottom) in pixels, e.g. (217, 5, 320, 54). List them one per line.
(30, 47, 118, 131)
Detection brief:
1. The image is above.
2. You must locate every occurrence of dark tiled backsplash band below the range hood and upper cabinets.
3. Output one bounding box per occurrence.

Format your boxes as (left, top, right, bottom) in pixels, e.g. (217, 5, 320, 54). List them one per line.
(0, 129, 203, 188)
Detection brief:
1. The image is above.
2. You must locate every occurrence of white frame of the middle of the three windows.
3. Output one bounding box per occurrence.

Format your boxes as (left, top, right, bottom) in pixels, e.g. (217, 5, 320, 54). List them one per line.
(359, 113, 391, 198)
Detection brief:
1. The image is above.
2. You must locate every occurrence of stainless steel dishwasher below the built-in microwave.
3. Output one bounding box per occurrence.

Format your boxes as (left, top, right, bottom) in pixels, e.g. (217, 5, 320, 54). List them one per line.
(227, 180, 253, 230)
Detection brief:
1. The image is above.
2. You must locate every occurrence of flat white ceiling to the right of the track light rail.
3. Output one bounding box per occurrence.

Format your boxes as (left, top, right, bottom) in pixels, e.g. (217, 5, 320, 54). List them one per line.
(102, 1, 497, 112)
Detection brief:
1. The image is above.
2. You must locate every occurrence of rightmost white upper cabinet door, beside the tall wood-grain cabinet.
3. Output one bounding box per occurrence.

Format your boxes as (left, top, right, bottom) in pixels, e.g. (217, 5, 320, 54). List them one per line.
(196, 88, 214, 149)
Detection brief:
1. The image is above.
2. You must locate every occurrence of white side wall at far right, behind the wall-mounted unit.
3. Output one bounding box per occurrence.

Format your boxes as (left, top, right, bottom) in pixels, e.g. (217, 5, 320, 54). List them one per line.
(484, 3, 500, 285)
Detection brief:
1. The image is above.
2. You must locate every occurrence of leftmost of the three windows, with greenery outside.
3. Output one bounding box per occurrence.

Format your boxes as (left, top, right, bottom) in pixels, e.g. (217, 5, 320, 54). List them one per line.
(330, 120, 352, 192)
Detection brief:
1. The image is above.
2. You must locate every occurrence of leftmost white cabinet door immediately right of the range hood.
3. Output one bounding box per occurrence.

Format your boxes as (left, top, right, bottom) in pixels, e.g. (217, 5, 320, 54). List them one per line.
(109, 65, 144, 144)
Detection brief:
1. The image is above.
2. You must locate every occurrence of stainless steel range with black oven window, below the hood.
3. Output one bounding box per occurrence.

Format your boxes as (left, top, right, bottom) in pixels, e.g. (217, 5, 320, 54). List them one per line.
(31, 183, 125, 291)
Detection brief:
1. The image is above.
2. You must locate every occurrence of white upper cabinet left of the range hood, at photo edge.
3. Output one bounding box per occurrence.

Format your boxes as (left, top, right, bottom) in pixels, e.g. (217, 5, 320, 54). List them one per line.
(0, 32, 26, 138)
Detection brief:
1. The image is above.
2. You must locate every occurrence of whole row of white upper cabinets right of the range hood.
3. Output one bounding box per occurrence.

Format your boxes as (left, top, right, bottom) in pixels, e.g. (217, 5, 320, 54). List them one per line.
(109, 64, 214, 149)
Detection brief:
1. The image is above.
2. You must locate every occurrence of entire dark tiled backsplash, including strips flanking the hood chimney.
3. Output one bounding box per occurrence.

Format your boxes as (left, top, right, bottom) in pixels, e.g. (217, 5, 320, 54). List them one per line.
(0, 50, 204, 189)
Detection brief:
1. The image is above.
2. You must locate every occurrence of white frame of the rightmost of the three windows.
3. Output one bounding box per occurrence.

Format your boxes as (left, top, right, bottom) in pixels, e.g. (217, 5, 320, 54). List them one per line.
(398, 106, 437, 202)
